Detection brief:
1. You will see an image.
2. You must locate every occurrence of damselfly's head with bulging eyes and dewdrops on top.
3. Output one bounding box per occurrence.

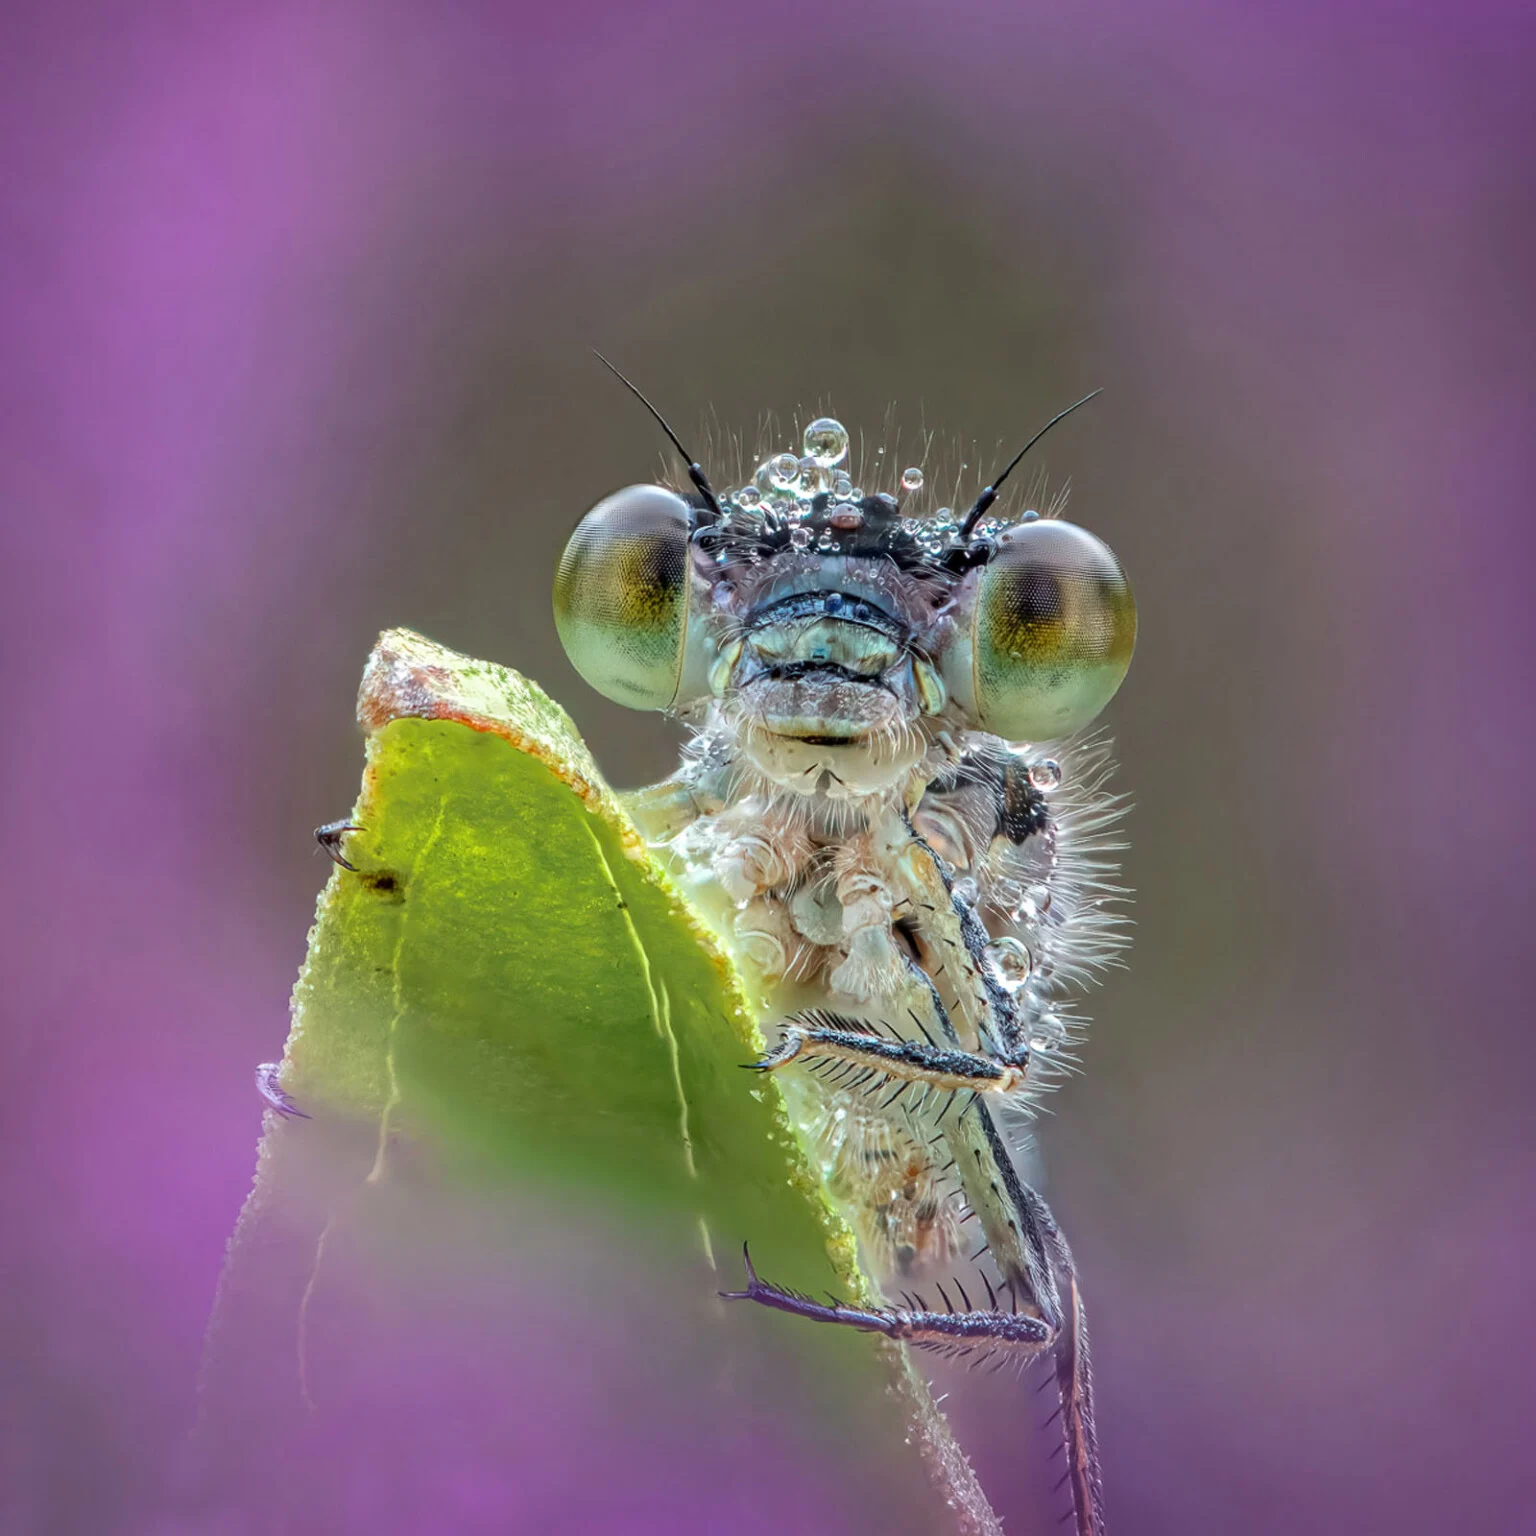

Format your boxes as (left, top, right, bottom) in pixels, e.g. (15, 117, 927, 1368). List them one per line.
(554, 402, 1137, 790)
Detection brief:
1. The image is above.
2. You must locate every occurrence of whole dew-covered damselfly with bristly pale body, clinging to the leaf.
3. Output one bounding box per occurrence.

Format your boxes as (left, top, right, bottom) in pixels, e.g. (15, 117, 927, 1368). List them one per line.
(554, 380, 1135, 1536)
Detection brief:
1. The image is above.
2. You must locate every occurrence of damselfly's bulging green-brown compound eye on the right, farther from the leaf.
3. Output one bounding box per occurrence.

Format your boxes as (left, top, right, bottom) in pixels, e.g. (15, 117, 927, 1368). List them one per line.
(969, 519, 1137, 740)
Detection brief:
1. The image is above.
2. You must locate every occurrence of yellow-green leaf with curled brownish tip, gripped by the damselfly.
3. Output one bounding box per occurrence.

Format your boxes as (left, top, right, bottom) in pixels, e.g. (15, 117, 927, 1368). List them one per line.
(206, 630, 995, 1531)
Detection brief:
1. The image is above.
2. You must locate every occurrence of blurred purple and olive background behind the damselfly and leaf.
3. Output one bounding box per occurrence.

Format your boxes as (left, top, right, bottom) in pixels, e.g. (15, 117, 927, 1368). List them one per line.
(0, 0, 1536, 1536)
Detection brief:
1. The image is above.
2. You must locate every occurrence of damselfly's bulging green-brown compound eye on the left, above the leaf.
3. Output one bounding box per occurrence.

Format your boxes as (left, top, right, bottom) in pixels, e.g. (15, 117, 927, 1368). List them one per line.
(554, 485, 690, 710)
